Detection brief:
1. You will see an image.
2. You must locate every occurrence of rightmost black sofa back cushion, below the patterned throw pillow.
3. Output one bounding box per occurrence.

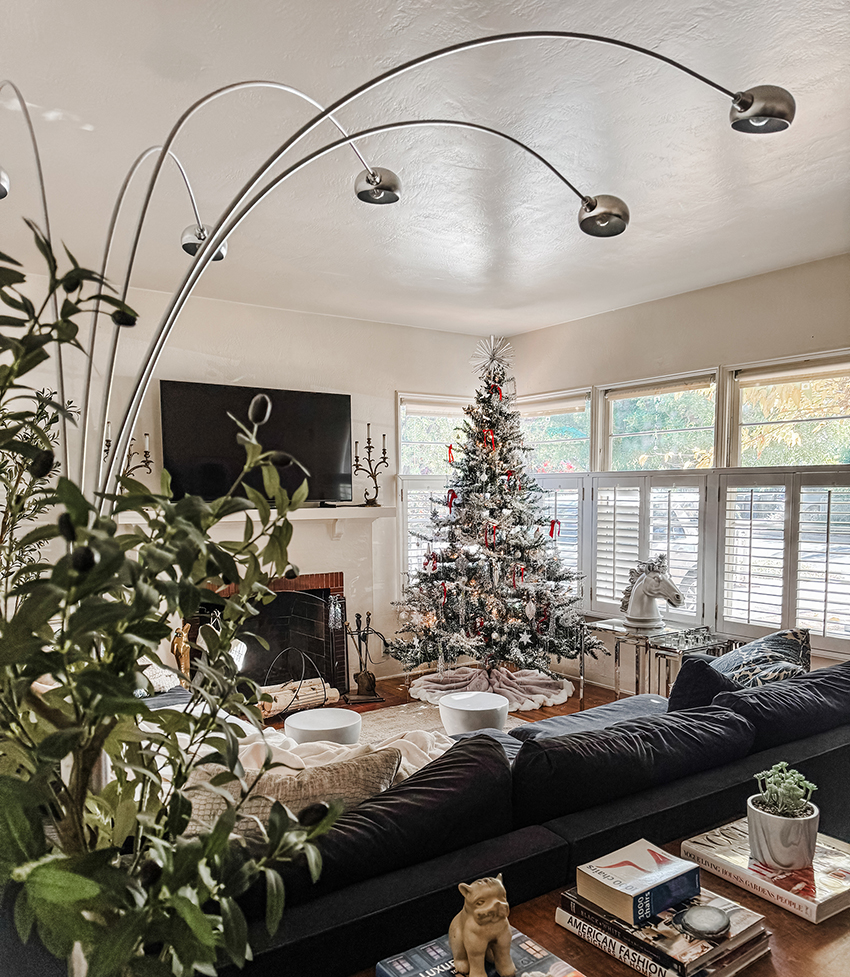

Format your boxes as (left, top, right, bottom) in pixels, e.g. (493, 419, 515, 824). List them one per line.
(714, 662, 850, 750)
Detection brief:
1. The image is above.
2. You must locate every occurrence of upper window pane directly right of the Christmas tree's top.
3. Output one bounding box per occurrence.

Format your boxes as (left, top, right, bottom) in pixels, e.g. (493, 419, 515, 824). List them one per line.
(517, 391, 590, 475)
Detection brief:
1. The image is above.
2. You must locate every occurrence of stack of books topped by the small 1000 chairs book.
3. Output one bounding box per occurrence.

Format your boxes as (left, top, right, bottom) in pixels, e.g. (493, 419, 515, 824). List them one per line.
(555, 840, 770, 977)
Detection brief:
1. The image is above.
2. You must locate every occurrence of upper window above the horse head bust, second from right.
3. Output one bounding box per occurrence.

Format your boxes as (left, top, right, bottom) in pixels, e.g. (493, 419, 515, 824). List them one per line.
(605, 375, 716, 471)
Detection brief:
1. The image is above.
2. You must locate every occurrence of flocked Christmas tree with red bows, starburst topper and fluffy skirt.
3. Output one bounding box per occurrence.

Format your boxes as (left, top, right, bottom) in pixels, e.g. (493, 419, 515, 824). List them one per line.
(392, 337, 601, 709)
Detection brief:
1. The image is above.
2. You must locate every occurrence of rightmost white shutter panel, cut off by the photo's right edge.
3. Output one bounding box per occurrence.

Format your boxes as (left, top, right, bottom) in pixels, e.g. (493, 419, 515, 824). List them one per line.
(796, 485, 850, 638)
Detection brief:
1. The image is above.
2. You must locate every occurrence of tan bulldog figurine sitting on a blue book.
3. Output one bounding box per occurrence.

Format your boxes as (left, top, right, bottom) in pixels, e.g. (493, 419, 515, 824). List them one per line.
(449, 873, 516, 977)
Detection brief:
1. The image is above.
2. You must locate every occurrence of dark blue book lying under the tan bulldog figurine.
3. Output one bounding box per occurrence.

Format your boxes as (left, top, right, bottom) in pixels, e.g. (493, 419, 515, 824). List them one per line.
(375, 926, 583, 977)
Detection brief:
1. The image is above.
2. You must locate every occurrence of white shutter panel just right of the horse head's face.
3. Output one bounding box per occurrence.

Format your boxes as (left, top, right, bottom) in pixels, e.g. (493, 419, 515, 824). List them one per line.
(649, 480, 704, 615)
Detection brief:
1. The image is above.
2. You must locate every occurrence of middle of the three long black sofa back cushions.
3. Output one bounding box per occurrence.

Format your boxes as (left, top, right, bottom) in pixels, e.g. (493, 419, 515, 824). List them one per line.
(513, 706, 755, 826)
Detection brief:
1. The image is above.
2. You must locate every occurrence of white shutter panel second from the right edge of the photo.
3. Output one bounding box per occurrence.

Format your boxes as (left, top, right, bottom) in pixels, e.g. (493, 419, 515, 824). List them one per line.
(721, 482, 787, 628)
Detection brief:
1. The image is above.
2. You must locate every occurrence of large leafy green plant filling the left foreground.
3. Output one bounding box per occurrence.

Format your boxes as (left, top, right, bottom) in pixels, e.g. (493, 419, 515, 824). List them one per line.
(0, 231, 338, 977)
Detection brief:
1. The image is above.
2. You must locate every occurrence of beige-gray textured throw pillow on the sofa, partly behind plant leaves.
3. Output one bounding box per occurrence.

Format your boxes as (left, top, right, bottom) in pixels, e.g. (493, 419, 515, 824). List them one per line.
(184, 747, 401, 839)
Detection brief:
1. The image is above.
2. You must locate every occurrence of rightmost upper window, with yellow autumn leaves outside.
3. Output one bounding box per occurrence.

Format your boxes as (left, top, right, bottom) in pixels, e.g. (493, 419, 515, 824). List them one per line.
(735, 363, 850, 467)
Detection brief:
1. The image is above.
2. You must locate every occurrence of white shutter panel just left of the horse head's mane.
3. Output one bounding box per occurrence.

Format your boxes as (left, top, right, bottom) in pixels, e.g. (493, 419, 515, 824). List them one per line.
(592, 482, 641, 605)
